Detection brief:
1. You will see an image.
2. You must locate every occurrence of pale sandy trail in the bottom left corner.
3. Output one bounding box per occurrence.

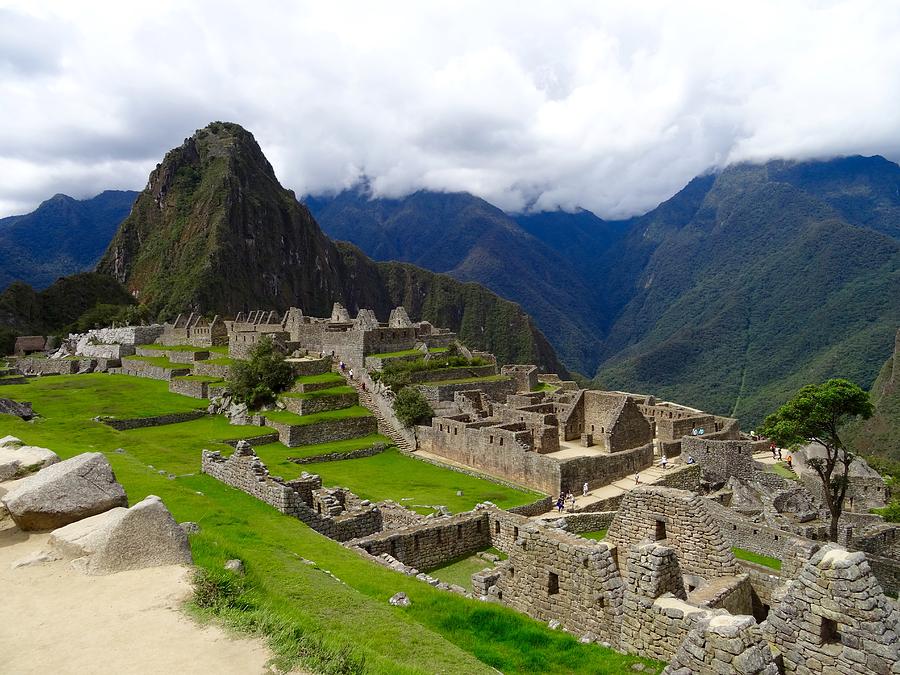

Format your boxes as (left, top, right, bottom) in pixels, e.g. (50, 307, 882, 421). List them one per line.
(0, 502, 271, 675)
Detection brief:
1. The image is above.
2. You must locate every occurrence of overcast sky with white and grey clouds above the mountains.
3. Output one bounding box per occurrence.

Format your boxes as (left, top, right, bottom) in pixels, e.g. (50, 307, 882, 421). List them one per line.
(0, 0, 900, 217)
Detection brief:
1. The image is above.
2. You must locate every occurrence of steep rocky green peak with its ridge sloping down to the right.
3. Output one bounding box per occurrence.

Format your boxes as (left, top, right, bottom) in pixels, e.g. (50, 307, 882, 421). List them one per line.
(97, 122, 567, 375)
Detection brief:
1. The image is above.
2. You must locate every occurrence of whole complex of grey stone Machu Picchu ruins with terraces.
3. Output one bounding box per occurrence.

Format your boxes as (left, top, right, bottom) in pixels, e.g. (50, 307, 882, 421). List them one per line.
(7, 303, 900, 675)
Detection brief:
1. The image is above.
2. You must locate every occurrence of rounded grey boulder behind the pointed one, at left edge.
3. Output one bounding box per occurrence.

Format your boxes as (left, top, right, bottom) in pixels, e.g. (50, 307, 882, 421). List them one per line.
(0, 452, 128, 530)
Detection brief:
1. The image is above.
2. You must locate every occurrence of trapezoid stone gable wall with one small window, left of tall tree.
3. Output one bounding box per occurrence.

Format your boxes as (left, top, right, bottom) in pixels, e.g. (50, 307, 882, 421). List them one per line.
(607, 486, 740, 580)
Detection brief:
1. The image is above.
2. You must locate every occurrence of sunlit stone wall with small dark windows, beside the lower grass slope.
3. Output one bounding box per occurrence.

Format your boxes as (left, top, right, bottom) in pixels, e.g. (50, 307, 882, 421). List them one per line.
(490, 509, 624, 645)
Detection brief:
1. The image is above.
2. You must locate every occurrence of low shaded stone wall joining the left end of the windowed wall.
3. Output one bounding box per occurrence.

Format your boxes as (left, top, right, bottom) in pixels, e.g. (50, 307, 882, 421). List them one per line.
(351, 511, 491, 571)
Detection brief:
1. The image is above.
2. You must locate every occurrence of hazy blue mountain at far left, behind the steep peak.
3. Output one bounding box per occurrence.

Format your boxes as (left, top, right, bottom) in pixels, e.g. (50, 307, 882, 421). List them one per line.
(0, 190, 138, 289)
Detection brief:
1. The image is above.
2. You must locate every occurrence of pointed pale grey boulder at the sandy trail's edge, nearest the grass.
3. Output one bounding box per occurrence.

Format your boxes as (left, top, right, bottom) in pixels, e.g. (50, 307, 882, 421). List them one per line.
(50, 495, 192, 574)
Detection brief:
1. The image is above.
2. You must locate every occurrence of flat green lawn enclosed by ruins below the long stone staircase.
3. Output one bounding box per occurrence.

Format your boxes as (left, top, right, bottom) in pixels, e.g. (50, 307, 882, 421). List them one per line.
(300, 448, 542, 513)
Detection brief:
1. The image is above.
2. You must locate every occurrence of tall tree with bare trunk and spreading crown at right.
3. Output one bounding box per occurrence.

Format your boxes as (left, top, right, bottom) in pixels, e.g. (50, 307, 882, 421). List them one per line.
(762, 379, 872, 541)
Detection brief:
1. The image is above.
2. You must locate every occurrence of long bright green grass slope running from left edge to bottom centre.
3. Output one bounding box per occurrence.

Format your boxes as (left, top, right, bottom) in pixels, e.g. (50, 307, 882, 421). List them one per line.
(0, 374, 662, 675)
